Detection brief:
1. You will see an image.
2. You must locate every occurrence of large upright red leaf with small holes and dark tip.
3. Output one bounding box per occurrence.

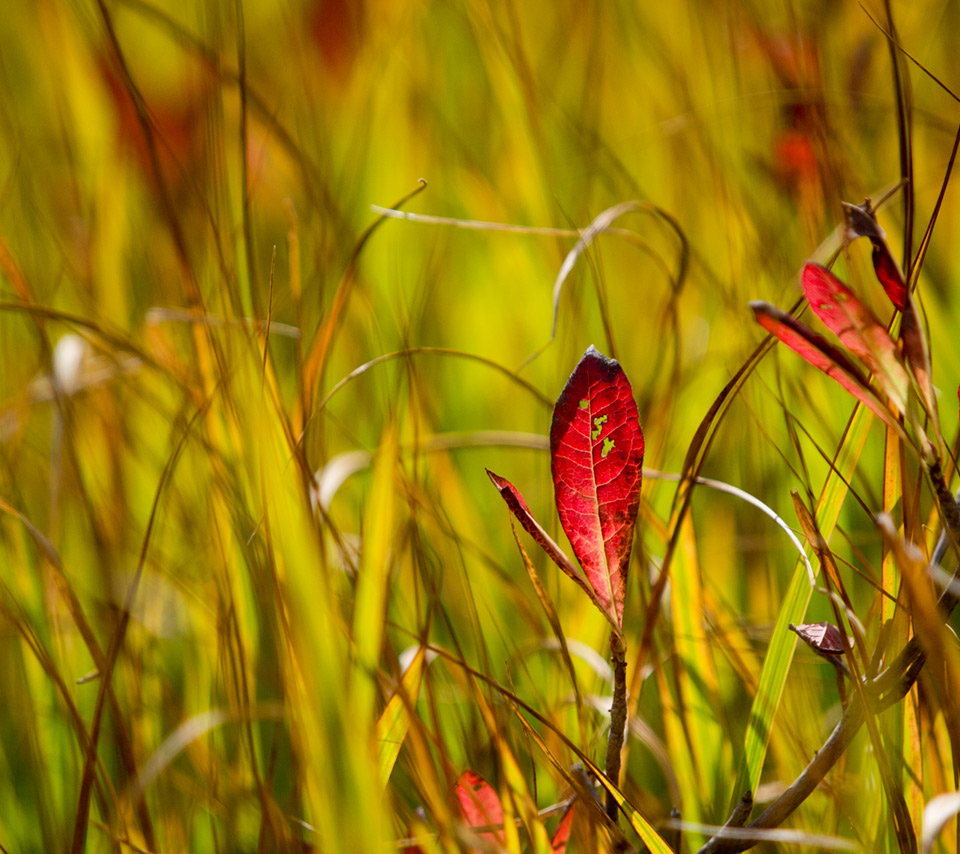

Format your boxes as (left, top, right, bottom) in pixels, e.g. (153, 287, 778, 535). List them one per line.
(550, 346, 643, 628)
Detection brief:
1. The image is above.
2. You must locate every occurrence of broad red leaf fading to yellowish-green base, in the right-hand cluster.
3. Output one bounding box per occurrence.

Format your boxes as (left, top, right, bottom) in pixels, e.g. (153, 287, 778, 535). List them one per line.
(803, 262, 910, 412)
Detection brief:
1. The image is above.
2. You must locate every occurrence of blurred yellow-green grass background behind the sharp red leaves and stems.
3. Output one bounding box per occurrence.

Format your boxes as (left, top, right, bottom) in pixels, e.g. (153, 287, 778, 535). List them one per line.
(0, 0, 960, 852)
